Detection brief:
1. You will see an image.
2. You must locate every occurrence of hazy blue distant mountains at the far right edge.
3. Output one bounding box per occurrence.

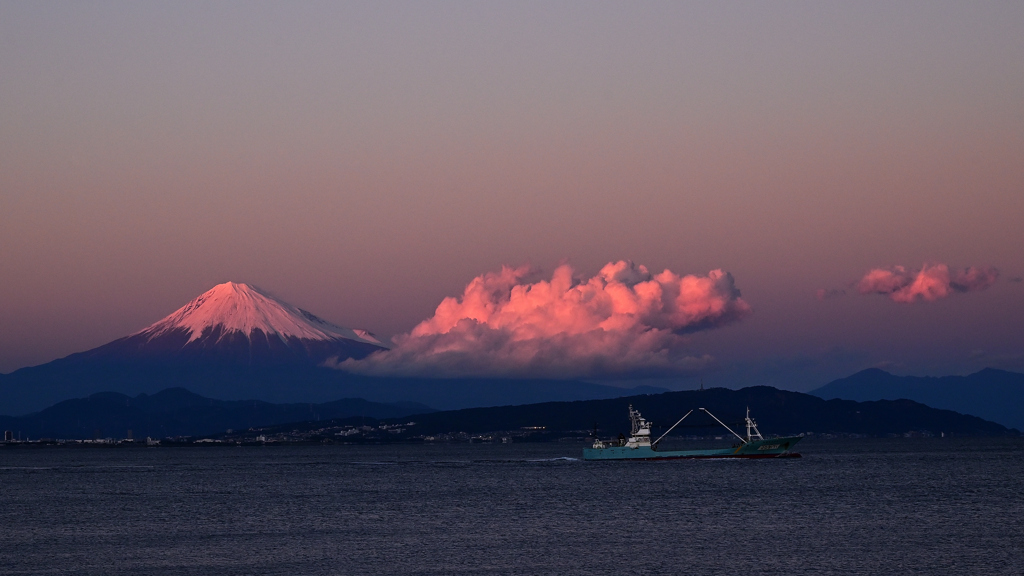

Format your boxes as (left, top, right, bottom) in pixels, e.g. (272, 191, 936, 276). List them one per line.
(811, 368, 1024, 430)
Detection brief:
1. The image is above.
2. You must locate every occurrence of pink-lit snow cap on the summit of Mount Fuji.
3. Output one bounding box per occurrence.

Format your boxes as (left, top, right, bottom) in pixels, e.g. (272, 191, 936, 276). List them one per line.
(136, 282, 384, 346)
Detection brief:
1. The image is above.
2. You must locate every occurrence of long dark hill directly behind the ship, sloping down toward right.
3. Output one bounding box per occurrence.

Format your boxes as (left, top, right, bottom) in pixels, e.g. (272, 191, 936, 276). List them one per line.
(258, 386, 1017, 437)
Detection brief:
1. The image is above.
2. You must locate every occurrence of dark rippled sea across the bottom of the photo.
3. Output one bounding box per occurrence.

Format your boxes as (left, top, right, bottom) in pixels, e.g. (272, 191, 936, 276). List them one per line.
(0, 439, 1024, 575)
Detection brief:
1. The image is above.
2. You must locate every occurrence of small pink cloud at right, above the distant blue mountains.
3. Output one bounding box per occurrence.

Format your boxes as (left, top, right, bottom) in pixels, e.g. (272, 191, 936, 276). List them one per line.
(856, 263, 999, 303)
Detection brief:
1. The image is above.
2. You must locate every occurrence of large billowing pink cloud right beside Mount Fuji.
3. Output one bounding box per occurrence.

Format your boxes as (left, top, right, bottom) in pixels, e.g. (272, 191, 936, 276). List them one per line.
(337, 260, 751, 378)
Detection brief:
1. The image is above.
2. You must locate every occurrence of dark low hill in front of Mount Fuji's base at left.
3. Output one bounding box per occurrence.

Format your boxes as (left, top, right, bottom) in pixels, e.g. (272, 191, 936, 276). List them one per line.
(0, 388, 432, 439)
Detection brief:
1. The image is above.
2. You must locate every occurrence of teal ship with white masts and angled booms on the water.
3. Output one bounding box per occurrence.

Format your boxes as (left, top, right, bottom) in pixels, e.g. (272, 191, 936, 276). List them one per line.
(583, 405, 803, 460)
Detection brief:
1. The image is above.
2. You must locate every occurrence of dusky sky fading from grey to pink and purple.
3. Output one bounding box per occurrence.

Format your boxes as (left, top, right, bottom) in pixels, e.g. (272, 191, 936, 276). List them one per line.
(0, 1, 1024, 389)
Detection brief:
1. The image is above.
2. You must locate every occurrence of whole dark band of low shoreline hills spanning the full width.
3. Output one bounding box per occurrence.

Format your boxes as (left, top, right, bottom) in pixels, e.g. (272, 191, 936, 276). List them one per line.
(0, 386, 1019, 443)
